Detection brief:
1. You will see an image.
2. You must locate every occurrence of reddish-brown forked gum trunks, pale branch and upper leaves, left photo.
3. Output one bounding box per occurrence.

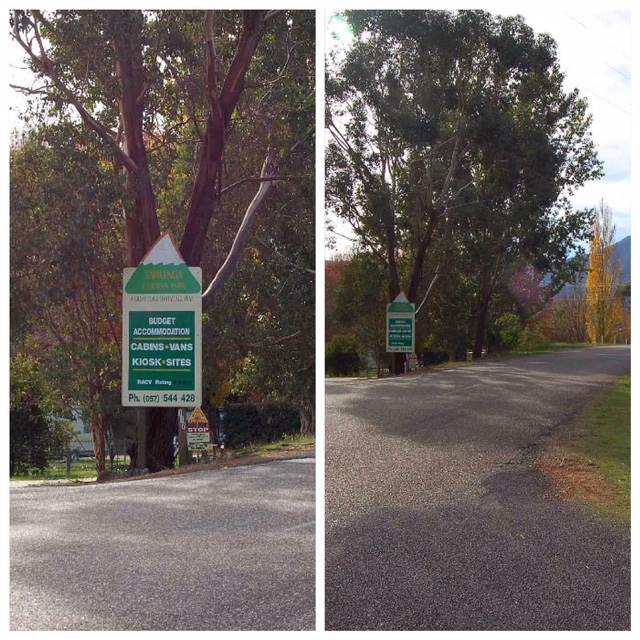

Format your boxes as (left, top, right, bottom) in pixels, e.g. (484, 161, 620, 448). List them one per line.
(10, 10, 316, 471)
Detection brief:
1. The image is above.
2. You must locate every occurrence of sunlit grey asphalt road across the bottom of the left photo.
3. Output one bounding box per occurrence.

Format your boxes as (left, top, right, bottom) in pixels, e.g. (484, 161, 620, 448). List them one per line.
(10, 458, 316, 630)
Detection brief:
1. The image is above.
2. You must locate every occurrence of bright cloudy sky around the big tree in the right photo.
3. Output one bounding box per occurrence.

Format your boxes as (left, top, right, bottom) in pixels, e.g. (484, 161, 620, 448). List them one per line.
(326, 2, 633, 255)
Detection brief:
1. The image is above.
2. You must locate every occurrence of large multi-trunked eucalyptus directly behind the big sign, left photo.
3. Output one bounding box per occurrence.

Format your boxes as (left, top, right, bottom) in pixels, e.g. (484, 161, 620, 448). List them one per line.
(10, 10, 315, 470)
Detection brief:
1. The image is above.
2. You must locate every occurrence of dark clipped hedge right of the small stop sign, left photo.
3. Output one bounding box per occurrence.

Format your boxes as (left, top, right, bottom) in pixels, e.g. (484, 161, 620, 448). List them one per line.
(222, 402, 300, 449)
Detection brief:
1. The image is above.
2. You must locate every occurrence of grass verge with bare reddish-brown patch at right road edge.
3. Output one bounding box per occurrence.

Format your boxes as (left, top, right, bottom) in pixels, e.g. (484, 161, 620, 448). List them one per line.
(541, 376, 631, 525)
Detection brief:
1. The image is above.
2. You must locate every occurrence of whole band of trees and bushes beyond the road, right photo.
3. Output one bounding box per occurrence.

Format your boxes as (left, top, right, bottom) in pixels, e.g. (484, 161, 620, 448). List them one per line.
(325, 10, 631, 377)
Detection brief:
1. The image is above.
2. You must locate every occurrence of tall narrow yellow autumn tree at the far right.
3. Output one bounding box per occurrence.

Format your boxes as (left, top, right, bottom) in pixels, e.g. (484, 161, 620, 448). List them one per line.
(587, 200, 623, 342)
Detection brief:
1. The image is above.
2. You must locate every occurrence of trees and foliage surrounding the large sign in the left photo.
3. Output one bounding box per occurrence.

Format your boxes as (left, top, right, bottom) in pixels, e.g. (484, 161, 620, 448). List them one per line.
(9, 9, 316, 476)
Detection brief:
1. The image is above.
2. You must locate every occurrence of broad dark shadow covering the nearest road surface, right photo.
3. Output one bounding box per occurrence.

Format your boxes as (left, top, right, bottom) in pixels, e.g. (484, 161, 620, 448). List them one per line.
(325, 469, 630, 630)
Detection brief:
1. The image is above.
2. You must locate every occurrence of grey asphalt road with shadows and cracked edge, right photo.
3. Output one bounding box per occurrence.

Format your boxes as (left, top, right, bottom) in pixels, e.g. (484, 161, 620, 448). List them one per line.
(325, 347, 630, 630)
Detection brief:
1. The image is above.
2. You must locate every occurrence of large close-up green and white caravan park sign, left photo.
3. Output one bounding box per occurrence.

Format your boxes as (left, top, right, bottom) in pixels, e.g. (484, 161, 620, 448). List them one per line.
(122, 234, 202, 407)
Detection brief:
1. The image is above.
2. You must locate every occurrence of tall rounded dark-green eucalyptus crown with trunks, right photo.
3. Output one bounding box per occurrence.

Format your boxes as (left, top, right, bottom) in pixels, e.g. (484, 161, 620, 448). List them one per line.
(327, 11, 600, 360)
